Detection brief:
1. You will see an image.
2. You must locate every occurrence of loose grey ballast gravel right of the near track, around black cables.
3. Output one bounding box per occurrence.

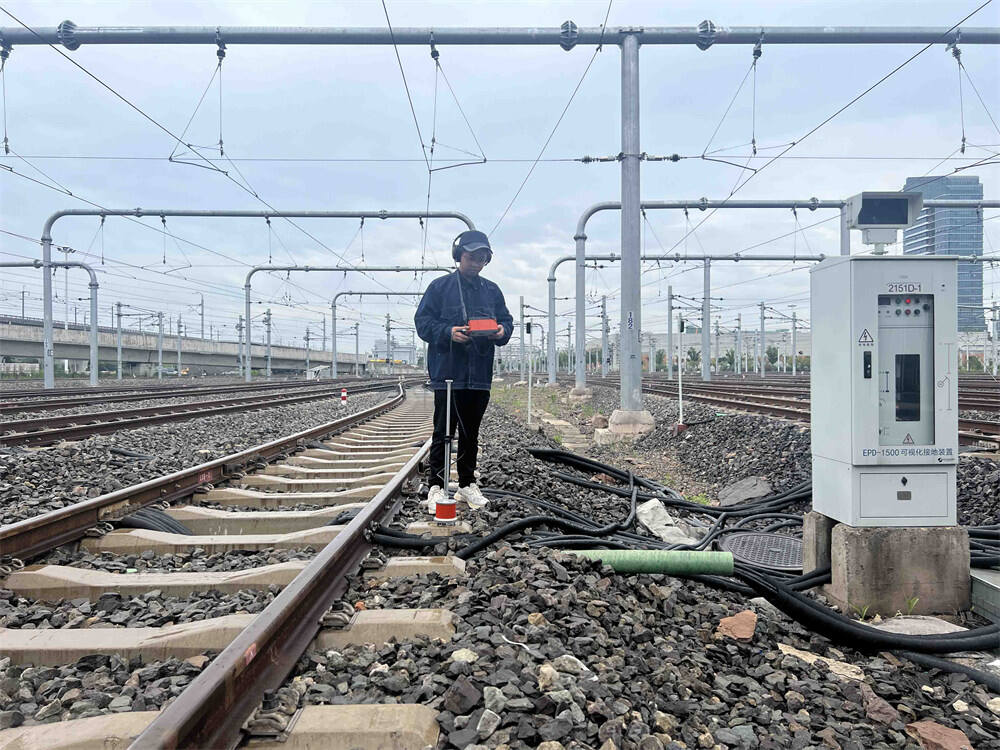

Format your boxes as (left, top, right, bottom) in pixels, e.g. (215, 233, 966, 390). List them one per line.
(282, 407, 1000, 750)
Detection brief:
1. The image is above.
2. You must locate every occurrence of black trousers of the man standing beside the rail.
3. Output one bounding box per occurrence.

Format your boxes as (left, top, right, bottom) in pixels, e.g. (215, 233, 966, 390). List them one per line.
(427, 389, 490, 487)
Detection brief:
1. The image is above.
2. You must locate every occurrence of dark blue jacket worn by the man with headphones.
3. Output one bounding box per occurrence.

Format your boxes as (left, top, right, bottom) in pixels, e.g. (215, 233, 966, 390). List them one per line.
(413, 271, 514, 391)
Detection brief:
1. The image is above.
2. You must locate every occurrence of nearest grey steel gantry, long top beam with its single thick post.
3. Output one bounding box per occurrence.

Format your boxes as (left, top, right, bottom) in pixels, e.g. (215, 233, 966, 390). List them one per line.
(15, 20, 1000, 424)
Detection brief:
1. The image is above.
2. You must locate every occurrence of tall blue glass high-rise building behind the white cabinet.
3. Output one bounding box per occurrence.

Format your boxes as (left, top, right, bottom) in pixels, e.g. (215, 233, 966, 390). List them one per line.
(903, 175, 986, 331)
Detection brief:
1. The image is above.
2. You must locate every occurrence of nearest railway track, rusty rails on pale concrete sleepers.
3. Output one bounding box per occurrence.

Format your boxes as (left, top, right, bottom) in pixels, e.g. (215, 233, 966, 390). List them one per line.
(0, 385, 452, 748)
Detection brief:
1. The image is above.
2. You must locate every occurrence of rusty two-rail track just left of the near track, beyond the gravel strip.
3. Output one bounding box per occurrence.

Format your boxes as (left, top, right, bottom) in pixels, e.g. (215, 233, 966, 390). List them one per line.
(0, 380, 406, 447)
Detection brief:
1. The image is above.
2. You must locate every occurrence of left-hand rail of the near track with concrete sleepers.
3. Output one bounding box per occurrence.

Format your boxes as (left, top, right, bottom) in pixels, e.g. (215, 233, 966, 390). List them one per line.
(0, 386, 403, 560)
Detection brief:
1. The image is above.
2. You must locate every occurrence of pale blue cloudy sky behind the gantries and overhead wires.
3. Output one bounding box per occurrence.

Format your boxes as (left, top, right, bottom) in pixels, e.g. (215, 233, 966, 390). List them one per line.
(0, 0, 1000, 350)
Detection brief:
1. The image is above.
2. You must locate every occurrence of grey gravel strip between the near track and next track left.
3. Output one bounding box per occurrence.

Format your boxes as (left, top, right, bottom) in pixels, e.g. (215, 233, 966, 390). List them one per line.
(0, 391, 392, 525)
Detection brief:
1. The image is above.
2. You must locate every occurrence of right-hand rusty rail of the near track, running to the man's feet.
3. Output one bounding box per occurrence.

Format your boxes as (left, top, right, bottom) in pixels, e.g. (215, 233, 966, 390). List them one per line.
(129, 418, 430, 750)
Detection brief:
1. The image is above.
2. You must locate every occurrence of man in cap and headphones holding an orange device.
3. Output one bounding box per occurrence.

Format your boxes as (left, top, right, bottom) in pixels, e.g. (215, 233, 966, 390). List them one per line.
(413, 231, 514, 512)
